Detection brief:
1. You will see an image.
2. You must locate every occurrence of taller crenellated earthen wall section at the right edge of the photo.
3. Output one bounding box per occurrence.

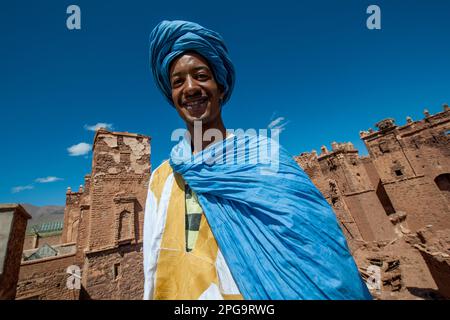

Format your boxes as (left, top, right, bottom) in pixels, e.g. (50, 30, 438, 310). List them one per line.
(362, 109, 450, 231)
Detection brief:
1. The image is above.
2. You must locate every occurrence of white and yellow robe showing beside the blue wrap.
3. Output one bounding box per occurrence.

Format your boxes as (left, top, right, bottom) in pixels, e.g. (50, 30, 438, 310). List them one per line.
(144, 161, 242, 300)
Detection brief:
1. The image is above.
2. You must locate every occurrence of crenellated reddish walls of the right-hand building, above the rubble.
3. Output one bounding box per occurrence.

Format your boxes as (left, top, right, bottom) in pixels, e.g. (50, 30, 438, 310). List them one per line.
(295, 105, 450, 248)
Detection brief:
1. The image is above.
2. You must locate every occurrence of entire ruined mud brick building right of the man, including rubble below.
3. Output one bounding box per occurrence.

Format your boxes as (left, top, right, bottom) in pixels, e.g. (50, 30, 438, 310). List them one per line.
(295, 105, 450, 299)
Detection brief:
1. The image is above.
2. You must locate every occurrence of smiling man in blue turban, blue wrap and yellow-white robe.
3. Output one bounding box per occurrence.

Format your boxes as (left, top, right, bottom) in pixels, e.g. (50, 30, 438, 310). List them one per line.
(144, 21, 371, 299)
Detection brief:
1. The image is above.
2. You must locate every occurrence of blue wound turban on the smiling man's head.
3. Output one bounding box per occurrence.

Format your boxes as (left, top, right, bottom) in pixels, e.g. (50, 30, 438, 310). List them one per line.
(150, 20, 235, 105)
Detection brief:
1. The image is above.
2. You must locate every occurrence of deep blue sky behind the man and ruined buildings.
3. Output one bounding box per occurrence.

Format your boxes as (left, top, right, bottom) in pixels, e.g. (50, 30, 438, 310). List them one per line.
(0, 0, 450, 205)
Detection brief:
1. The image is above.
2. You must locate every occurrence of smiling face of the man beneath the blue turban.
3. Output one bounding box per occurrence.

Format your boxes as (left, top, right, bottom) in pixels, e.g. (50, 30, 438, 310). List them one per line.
(169, 53, 223, 125)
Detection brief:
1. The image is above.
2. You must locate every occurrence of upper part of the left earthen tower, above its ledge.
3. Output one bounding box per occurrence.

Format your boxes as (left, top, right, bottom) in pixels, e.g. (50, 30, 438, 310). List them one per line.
(84, 132, 150, 250)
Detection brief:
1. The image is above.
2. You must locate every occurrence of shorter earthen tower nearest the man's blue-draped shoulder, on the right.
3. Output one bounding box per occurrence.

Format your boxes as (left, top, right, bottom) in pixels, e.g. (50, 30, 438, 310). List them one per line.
(296, 142, 395, 241)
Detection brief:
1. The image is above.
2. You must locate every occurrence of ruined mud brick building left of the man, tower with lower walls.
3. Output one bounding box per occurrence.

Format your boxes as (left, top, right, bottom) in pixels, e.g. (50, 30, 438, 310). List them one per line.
(17, 129, 150, 299)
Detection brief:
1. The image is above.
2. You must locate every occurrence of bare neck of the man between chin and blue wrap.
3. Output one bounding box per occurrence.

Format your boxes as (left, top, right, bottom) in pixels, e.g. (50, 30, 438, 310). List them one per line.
(187, 119, 227, 154)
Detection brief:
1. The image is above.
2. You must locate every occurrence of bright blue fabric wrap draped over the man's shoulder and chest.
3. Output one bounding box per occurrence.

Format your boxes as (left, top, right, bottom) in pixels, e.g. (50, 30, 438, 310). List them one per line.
(170, 136, 372, 300)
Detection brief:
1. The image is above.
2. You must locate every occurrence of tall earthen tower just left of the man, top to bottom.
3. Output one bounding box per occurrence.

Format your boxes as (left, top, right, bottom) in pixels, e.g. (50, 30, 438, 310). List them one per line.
(79, 131, 150, 299)
